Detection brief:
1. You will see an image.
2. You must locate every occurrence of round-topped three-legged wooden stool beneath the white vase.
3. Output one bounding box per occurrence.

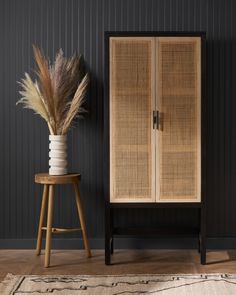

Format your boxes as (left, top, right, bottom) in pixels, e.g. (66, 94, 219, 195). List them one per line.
(35, 173, 91, 267)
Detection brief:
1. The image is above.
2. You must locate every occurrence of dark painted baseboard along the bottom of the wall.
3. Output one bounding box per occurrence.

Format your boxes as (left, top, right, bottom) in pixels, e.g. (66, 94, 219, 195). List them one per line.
(0, 237, 236, 249)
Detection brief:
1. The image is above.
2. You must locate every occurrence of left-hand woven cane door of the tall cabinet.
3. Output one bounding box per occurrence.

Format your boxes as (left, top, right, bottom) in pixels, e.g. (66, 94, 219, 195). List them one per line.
(109, 37, 155, 202)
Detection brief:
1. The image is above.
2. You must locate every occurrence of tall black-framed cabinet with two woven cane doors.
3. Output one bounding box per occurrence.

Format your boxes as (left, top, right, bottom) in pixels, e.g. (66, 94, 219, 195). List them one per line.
(104, 32, 205, 264)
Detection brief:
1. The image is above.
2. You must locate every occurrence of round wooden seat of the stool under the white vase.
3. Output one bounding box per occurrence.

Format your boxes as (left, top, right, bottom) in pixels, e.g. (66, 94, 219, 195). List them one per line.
(35, 173, 81, 184)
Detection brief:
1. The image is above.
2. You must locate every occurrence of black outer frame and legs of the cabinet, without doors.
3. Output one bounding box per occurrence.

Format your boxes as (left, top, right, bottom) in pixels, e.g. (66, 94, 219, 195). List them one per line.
(103, 31, 207, 265)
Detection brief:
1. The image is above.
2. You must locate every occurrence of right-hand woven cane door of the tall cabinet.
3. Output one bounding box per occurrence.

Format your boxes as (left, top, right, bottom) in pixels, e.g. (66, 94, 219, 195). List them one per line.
(156, 37, 201, 202)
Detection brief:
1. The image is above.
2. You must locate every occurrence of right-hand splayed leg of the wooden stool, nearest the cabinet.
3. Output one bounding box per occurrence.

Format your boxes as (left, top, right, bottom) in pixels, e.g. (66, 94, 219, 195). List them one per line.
(74, 181, 92, 257)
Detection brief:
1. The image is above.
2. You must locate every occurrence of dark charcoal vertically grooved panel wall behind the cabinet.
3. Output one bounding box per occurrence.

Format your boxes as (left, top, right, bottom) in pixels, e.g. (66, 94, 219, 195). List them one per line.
(0, 0, 236, 247)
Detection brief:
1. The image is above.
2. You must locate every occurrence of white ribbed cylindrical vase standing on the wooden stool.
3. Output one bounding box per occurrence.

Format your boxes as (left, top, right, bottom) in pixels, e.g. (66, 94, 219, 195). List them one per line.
(49, 135, 67, 175)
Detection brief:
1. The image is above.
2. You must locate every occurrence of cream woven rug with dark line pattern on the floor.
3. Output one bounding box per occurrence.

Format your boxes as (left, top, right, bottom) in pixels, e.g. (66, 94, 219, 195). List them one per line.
(0, 274, 236, 295)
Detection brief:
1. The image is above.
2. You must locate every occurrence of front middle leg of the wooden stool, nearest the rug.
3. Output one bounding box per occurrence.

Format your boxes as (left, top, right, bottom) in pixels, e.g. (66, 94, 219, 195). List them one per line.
(44, 185, 54, 267)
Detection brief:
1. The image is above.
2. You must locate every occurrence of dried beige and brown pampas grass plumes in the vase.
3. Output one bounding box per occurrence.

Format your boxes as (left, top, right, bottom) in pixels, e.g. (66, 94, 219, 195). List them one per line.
(17, 46, 89, 135)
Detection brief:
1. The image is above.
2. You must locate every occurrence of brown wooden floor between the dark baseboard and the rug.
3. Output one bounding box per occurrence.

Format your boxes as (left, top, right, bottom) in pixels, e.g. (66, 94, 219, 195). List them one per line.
(0, 250, 236, 280)
